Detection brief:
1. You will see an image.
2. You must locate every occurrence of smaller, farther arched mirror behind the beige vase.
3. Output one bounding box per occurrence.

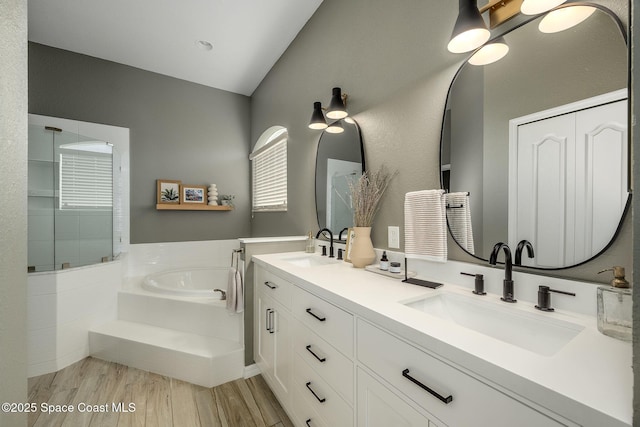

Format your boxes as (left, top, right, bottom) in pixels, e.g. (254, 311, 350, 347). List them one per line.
(316, 118, 365, 238)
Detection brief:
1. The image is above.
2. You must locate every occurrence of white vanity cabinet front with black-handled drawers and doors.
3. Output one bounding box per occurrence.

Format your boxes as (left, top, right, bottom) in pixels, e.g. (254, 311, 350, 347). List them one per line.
(254, 263, 577, 427)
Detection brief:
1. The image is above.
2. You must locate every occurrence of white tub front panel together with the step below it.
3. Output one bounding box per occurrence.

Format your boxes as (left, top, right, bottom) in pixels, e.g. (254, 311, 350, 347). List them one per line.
(89, 279, 244, 387)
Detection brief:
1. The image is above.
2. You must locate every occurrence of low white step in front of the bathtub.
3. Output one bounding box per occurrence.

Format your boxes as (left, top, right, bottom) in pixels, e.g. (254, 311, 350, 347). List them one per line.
(89, 320, 244, 387)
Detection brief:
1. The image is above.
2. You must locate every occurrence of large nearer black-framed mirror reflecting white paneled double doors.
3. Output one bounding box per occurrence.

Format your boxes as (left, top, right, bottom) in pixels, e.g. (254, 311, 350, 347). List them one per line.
(441, 3, 630, 269)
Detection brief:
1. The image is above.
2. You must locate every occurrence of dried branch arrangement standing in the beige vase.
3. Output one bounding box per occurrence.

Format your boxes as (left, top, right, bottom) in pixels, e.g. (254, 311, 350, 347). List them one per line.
(349, 166, 398, 227)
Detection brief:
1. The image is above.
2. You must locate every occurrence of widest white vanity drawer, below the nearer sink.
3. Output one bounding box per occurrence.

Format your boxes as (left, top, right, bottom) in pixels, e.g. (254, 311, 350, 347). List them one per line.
(357, 320, 563, 427)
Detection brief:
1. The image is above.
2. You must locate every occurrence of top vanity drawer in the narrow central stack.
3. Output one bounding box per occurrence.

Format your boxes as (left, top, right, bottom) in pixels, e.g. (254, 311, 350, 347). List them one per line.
(292, 287, 354, 357)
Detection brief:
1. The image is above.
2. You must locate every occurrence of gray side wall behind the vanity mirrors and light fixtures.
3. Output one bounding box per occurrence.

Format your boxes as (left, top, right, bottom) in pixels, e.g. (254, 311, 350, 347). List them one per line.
(251, 0, 631, 282)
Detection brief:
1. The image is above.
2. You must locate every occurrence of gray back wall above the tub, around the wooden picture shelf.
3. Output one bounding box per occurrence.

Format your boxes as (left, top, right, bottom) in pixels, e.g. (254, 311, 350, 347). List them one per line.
(29, 43, 250, 243)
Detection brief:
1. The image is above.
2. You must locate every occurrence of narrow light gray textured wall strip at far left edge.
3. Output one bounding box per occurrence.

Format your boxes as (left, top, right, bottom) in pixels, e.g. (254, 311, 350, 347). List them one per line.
(0, 0, 27, 427)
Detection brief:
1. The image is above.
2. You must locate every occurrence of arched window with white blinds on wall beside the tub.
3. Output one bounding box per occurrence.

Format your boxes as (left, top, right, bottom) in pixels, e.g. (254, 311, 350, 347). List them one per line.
(249, 126, 289, 212)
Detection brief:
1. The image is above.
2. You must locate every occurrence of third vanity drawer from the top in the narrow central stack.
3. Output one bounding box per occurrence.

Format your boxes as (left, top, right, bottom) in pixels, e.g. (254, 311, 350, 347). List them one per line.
(293, 354, 353, 426)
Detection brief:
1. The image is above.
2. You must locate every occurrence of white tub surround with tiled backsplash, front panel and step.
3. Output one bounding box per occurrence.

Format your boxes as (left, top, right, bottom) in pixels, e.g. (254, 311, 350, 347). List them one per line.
(89, 240, 245, 387)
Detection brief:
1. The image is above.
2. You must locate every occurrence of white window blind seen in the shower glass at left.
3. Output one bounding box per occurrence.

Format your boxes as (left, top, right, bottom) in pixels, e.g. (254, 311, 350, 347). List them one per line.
(59, 153, 113, 209)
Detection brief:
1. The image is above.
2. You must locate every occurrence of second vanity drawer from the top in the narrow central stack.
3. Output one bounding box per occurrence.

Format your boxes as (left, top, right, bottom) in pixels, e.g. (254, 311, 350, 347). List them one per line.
(293, 323, 354, 404)
